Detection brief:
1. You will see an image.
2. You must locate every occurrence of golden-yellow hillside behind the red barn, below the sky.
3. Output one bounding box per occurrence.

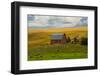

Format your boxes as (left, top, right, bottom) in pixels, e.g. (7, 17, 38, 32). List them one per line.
(28, 27, 88, 47)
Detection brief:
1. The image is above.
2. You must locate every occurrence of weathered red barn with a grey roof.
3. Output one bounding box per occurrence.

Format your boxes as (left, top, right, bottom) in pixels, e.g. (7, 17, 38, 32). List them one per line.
(51, 33, 67, 44)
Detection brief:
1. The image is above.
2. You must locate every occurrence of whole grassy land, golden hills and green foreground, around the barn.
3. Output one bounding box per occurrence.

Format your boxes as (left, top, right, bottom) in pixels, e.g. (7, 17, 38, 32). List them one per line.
(28, 27, 88, 61)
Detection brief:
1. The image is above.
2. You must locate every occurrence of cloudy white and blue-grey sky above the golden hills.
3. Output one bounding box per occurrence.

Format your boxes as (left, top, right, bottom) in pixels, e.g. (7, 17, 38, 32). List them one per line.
(27, 14, 88, 28)
